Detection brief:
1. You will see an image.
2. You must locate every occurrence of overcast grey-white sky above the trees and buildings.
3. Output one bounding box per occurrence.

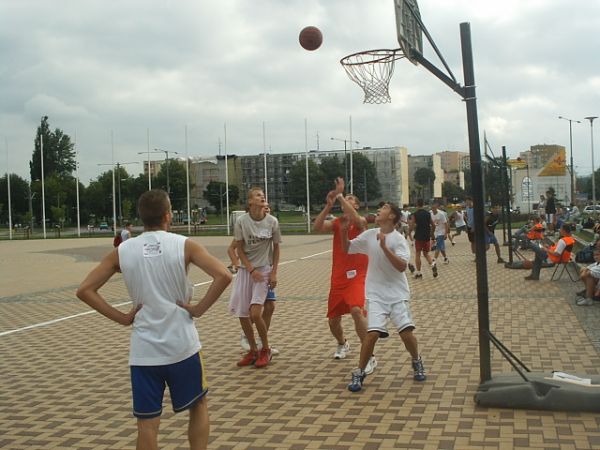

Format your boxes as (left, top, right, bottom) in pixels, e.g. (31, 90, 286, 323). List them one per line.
(0, 0, 600, 185)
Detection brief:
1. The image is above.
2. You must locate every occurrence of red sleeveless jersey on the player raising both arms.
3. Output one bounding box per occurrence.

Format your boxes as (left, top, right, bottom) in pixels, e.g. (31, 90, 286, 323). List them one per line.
(331, 218, 369, 289)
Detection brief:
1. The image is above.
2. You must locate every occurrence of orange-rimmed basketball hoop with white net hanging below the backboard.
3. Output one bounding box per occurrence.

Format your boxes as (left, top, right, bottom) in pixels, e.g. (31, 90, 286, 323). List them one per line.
(340, 48, 404, 104)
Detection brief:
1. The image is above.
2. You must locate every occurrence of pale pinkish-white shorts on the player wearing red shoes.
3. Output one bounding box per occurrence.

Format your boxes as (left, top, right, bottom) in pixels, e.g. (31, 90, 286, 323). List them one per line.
(229, 266, 271, 317)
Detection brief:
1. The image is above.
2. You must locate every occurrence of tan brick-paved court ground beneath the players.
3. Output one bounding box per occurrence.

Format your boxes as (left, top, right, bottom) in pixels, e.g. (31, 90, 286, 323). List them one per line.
(0, 235, 600, 449)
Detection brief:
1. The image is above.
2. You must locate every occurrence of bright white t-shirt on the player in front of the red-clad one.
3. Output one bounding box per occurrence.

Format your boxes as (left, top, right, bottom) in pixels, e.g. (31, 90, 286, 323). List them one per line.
(348, 228, 410, 303)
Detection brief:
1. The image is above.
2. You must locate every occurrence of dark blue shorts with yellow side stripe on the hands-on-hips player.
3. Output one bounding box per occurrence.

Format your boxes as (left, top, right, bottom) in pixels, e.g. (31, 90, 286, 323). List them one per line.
(130, 353, 208, 419)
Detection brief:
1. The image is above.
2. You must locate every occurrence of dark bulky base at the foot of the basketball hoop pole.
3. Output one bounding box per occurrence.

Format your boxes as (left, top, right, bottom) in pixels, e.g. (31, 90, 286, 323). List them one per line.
(475, 372, 600, 413)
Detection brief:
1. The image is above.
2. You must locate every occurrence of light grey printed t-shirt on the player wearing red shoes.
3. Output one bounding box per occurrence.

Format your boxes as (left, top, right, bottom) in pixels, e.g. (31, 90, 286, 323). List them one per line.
(233, 213, 281, 267)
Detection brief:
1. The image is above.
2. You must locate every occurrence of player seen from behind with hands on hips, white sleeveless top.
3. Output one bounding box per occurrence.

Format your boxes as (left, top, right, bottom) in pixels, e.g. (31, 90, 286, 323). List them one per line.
(77, 189, 232, 449)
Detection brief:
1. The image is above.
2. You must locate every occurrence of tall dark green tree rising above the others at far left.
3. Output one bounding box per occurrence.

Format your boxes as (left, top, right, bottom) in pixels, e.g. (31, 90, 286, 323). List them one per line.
(29, 116, 75, 180)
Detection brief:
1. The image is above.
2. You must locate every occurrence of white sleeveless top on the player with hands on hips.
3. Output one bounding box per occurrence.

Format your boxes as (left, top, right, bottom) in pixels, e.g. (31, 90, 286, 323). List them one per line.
(117, 231, 202, 366)
